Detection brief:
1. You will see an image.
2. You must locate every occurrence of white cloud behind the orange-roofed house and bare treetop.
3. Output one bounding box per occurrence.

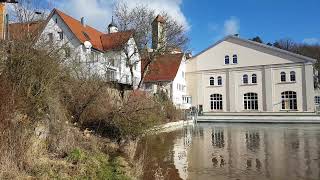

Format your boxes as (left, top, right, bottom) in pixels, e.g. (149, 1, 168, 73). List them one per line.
(55, 0, 189, 31)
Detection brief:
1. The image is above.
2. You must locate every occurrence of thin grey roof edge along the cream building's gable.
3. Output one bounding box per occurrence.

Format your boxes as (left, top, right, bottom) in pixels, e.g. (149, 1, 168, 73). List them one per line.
(193, 35, 317, 63)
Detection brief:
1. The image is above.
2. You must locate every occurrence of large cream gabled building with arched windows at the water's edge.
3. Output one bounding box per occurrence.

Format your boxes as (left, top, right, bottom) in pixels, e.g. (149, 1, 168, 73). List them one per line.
(186, 36, 316, 112)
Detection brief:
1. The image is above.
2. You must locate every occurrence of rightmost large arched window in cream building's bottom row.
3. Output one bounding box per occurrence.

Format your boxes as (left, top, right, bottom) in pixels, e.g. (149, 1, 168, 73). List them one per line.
(281, 91, 298, 110)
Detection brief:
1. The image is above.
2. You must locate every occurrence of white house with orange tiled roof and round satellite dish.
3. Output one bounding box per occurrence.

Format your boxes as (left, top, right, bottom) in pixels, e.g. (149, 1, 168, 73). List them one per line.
(35, 9, 141, 86)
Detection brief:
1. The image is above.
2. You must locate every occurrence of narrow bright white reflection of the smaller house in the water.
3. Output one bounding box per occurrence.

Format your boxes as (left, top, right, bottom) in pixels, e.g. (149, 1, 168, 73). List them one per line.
(173, 127, 193, 180)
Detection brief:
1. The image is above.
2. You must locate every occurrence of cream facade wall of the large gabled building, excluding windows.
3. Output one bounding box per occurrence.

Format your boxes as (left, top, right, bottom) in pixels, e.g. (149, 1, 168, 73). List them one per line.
(186, 38, 314, 112)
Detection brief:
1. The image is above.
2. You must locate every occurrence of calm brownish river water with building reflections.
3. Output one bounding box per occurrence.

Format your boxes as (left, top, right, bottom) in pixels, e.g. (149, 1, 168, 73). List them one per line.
(137, 124, 320, 180)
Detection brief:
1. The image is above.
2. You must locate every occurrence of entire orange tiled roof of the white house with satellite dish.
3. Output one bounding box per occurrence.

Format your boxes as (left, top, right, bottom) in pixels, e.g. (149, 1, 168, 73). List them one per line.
(54, 9, 133, 51)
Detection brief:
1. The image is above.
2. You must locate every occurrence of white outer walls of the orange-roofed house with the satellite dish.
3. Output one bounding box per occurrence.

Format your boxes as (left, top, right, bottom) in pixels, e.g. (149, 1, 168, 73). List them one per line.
(39, 14, 141, 86)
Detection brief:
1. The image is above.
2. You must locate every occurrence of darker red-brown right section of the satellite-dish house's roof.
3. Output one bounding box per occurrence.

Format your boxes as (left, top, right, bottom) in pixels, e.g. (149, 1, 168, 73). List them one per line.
(100, 31, 133, 51)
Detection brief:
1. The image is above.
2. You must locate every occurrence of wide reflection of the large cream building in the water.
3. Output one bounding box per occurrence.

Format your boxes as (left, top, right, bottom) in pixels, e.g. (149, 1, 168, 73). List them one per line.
(188, 126, 320, 179)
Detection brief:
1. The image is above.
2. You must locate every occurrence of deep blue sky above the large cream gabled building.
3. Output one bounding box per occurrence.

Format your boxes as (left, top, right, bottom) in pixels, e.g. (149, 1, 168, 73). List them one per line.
(182, 0, 320, 52)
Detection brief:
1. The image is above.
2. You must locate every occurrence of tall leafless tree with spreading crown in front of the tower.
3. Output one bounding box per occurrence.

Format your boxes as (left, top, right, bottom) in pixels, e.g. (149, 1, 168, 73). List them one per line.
(115, 3, 188, 88)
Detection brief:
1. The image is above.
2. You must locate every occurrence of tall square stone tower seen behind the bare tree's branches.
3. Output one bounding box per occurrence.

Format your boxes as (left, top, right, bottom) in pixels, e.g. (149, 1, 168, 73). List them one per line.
(152, 15, 166, 49)
